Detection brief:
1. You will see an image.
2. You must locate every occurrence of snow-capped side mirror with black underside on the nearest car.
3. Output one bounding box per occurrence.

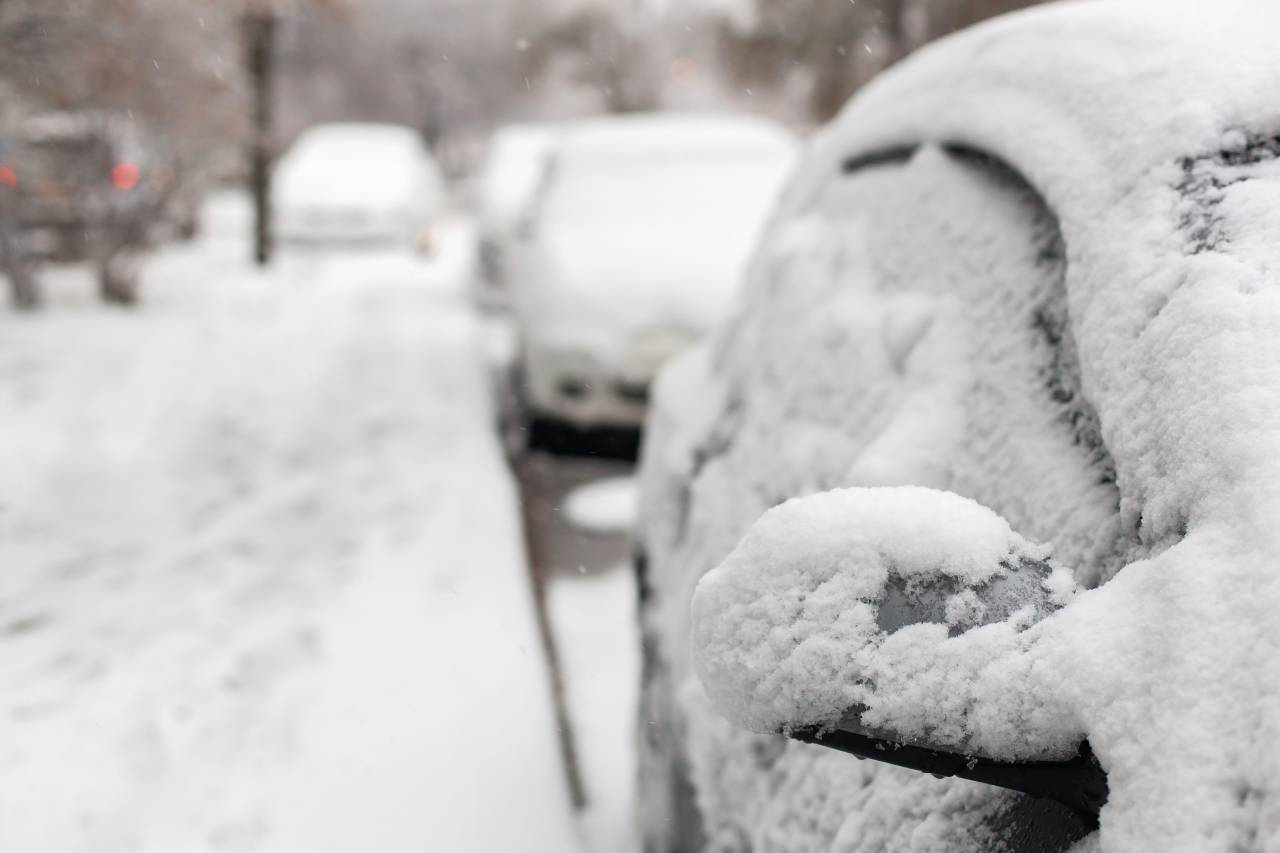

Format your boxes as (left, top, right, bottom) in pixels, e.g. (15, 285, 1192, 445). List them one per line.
(692, 487, 1107, 821)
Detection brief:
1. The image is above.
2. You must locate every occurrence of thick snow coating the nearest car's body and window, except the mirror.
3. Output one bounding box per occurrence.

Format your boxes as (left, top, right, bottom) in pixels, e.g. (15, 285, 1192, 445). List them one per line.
(645, 1, 1280, 850)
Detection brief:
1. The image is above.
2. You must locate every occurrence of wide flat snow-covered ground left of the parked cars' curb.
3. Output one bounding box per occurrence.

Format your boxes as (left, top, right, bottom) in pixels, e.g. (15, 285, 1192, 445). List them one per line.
(0, 194, 577, 853)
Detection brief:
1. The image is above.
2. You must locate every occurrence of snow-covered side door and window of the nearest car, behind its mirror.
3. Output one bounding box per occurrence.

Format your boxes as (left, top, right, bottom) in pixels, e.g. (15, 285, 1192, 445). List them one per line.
(634, 146, 1116, 850)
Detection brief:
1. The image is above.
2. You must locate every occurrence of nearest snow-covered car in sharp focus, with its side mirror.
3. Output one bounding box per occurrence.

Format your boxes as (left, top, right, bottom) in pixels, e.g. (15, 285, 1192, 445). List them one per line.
(637, 3, 1280, 852)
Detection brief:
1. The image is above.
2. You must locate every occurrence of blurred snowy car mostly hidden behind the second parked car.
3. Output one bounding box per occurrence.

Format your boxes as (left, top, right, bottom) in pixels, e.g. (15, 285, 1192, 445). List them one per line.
(475, 124, 558, 306)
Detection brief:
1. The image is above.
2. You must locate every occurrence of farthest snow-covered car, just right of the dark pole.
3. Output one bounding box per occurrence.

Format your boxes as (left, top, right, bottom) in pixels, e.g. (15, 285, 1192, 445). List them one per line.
(273, 124, 444, 247)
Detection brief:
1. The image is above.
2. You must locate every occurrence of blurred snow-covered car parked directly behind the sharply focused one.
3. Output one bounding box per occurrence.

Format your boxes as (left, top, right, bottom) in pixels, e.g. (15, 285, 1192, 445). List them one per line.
(512, 114, 796, 441)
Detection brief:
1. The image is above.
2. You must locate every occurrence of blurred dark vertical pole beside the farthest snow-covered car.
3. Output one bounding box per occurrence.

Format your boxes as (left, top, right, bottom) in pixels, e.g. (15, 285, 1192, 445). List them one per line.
(241, 10, 275, 266)
